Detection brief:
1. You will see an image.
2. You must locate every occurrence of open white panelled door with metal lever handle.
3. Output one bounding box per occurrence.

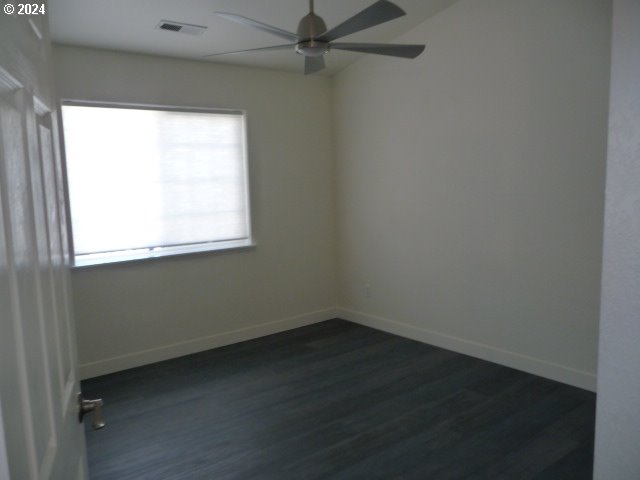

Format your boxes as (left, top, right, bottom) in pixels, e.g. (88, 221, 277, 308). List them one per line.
(0, 7, 87, 480)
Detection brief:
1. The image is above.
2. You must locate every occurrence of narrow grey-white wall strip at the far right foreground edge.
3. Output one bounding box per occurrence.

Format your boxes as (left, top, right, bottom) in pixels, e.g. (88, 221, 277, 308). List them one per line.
(594, 0, 640, 480)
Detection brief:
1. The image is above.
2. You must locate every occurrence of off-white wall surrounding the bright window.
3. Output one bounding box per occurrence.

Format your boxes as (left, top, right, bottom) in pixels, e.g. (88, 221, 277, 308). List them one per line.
(54, 46, 336, 377)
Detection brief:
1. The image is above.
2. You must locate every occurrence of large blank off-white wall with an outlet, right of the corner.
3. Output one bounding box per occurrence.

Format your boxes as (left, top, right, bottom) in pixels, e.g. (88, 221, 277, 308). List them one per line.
(334, 0, 611, 389)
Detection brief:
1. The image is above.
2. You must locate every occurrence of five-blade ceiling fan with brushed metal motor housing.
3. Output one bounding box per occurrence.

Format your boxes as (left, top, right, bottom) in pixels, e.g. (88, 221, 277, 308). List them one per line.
(206, 0, 425, 75)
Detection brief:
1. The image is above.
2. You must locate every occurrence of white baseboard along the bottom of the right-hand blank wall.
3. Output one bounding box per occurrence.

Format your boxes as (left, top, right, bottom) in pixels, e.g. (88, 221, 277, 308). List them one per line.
(336, 308, 596, 392)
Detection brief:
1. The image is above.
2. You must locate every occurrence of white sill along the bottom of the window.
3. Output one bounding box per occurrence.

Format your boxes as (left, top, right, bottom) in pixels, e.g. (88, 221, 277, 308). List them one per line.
(71, 240, 256, 270)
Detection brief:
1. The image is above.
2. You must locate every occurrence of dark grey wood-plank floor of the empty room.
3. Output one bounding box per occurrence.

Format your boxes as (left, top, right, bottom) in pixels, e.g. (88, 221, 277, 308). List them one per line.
(83, 320, 595, 480)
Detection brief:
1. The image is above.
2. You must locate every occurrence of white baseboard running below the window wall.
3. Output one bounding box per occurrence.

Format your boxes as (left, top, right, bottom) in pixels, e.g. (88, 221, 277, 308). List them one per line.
(80, 308, 336, 380)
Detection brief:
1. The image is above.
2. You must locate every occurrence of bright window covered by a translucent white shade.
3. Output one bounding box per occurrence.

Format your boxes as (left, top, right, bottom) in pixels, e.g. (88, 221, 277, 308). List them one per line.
(62, 102, 251, 266)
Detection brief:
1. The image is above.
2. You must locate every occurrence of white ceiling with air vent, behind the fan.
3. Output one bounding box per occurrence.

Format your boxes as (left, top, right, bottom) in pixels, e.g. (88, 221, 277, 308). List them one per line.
(49, 0, 457, 75)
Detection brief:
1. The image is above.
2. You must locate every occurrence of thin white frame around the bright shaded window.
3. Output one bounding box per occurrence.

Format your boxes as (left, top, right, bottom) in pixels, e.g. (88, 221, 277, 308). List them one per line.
(58, 98, 257, 270)
